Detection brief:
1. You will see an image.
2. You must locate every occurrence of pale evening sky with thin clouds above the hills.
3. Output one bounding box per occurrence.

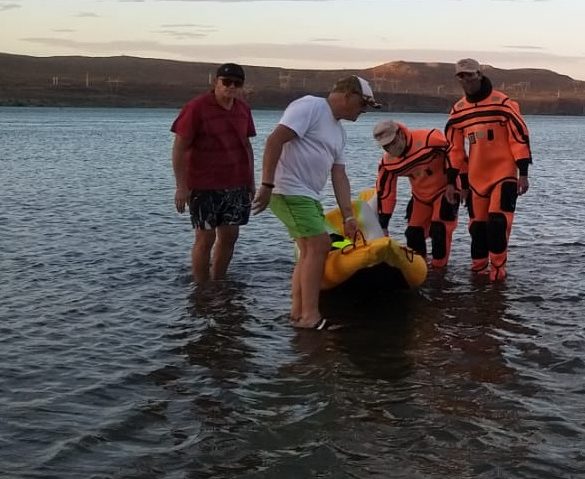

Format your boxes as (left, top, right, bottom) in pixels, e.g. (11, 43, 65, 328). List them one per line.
(0, 0, 585, 80)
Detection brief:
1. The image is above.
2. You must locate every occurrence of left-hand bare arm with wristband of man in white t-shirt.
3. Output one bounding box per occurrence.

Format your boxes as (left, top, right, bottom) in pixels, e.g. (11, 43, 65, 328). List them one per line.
(252, 124, 297, 215)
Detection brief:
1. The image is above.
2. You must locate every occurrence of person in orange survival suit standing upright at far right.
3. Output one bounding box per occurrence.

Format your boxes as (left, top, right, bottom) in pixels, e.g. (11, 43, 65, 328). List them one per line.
(445, 58, 532, 281)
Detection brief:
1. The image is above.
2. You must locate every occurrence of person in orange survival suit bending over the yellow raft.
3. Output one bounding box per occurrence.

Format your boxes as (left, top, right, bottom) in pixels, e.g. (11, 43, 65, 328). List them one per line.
(373, 120, 459, 268)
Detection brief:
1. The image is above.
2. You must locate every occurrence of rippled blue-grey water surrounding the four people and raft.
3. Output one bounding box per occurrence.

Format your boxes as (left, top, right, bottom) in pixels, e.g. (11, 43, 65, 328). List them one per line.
(0, 108, 585, 479)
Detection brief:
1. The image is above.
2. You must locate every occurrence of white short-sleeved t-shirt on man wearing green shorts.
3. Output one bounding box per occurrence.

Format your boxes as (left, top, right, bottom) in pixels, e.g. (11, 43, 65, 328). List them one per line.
(274, 95, 346, 200)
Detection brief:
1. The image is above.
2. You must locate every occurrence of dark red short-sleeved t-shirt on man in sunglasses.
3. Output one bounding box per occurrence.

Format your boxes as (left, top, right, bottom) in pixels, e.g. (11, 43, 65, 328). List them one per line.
(171, 92, 256, 190)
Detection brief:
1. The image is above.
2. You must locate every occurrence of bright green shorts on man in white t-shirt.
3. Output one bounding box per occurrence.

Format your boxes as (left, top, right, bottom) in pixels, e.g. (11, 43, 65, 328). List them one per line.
(270, 194, 326, 239)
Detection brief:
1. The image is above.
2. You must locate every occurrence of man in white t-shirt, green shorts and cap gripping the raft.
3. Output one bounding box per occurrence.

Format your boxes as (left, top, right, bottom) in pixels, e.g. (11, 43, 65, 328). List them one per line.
(252, 75, 380, 330)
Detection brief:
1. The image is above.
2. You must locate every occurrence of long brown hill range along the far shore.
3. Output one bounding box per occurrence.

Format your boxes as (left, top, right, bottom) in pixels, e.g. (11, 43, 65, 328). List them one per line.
(0, 53, 585, 115)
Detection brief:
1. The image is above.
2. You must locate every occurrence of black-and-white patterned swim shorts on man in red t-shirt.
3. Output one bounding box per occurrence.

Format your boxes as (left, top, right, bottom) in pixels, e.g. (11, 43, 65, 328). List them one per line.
(189, 187, 252, 230)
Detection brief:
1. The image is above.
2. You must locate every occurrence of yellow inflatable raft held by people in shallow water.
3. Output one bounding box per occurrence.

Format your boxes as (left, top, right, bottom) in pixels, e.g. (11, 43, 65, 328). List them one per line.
(321, 194, 427, 290)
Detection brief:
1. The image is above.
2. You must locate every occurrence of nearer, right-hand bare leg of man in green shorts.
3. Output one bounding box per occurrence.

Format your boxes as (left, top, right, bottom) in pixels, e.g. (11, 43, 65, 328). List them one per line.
(297, 233, 330, 328)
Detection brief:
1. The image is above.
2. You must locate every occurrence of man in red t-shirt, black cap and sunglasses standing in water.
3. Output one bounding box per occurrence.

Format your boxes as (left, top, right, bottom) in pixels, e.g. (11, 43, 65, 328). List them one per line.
(171, 63, 256, 283)
